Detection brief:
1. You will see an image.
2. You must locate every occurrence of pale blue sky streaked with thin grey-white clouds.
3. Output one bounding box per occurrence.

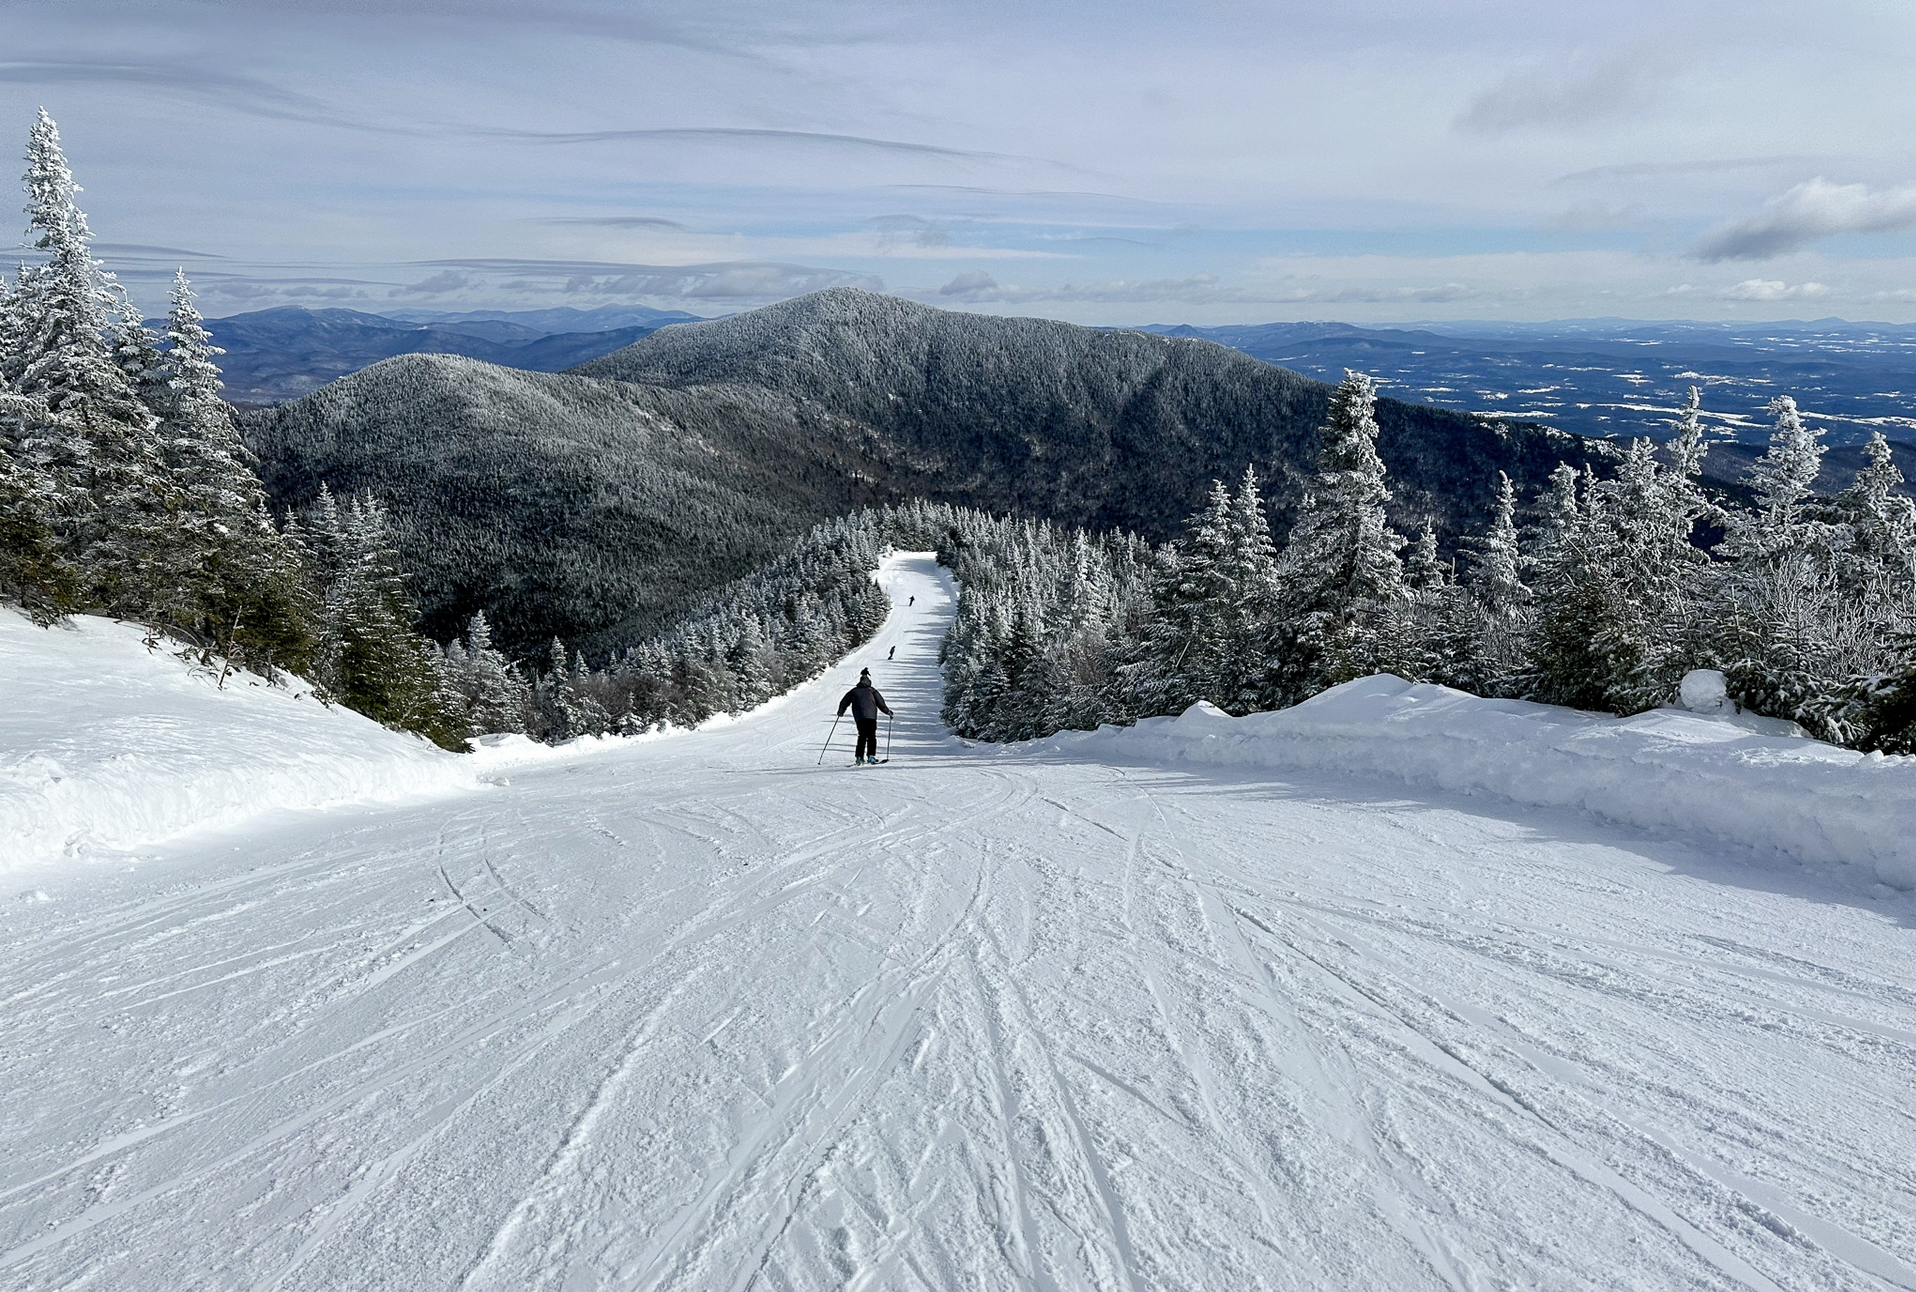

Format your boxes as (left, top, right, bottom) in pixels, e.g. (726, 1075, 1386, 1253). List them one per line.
(0, 0, 1916, 324)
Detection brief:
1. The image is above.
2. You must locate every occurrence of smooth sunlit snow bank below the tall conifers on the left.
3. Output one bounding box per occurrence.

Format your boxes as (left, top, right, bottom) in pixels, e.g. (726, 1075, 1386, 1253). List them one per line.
(0, 608, 486, 872)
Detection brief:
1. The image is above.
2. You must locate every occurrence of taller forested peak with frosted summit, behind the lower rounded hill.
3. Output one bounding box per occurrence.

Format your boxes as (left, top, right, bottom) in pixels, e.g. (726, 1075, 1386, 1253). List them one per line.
(571, 288, 1608, 539)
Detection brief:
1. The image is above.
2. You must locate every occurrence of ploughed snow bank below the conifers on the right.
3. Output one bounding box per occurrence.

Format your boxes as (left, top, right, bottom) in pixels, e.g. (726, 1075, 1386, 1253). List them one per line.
(1044, 675, 1916, 889)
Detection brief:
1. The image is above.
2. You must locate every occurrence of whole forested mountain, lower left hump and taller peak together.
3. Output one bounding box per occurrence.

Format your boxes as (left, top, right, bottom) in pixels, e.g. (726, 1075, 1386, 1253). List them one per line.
(247, 289, 1608, 656)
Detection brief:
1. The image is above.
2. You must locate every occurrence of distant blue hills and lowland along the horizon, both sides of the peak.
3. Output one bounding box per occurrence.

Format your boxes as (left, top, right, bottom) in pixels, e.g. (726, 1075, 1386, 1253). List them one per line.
(207, 305, 1916, 458)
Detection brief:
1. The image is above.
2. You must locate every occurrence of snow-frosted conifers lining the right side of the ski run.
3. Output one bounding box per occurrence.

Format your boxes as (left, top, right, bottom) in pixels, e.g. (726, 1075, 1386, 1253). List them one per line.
(927, 374, 1916, 753)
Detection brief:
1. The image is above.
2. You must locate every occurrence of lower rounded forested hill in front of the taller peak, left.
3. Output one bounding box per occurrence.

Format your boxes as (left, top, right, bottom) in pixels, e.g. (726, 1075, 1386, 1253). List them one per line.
(247, 355, 899, 656)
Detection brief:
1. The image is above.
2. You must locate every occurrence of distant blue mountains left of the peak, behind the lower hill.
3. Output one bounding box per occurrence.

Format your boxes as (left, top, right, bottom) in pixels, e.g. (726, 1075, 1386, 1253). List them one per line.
(196, 305, 697, 404)
